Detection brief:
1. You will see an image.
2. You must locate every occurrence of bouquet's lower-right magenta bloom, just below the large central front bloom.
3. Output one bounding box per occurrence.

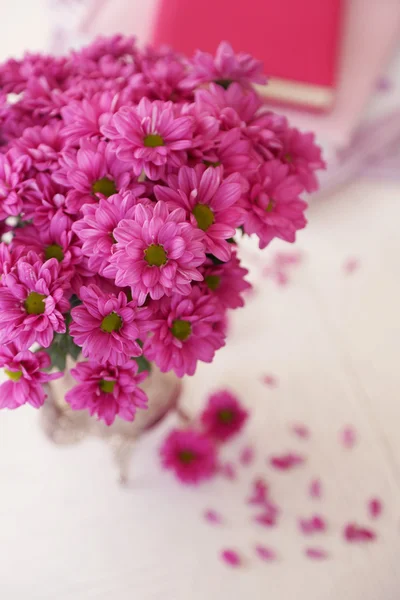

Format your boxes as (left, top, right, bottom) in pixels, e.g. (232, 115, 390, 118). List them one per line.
(143, 287, 225, 377)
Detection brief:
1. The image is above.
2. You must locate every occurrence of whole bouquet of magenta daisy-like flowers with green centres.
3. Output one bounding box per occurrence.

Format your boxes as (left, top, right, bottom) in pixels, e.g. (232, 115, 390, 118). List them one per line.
(0, 36, 324, 425)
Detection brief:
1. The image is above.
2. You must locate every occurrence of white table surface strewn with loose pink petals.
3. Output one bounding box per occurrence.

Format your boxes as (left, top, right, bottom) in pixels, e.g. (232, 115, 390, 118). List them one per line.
(0, 180, 400, 600)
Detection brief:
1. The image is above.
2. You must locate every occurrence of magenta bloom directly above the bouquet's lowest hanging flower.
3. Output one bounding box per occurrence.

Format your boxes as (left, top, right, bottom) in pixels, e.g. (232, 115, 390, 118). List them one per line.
(69, 285, 152, 365)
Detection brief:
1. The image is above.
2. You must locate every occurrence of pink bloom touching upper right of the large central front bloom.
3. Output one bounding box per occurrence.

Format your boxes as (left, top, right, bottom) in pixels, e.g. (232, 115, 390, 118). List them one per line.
(154, 165, 244, 262)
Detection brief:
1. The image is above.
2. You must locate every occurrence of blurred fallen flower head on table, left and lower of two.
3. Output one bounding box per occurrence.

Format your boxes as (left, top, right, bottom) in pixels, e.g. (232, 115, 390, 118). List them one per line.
(160, 429, 217, 484)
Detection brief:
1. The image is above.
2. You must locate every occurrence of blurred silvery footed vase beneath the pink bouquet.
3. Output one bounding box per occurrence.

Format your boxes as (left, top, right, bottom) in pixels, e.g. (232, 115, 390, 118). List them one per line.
(41, 357, 184, 484)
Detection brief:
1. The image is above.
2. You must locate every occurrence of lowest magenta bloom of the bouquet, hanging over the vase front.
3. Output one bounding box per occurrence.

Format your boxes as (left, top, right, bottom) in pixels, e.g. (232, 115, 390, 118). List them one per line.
(65, 360, 147, 425)
